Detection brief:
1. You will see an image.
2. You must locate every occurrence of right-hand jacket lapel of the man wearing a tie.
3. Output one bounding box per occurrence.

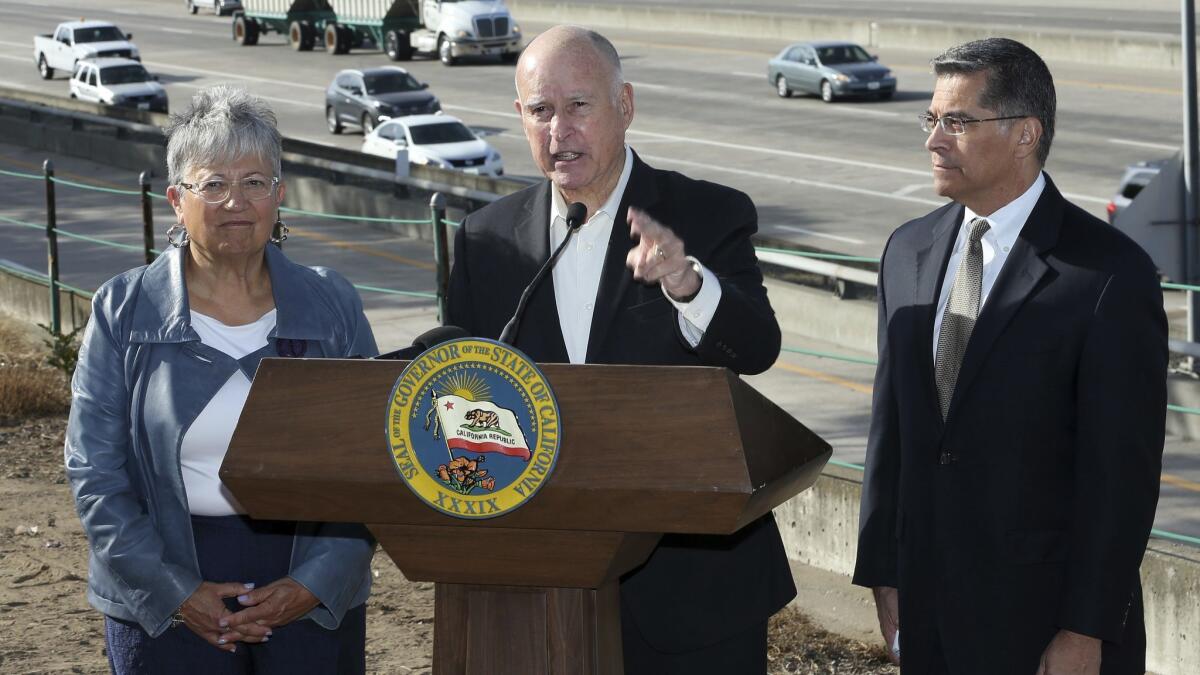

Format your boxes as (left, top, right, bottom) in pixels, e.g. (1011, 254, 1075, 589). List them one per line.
(950, 177, 1064, 417)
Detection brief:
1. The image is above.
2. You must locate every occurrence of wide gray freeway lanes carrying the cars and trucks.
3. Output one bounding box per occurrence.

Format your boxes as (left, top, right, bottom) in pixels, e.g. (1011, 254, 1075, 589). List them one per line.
(0, 0, 1182, 256)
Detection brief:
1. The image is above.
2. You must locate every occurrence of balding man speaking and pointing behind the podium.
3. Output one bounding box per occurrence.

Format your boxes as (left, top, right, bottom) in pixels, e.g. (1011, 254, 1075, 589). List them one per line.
(448, 26, 796, 675)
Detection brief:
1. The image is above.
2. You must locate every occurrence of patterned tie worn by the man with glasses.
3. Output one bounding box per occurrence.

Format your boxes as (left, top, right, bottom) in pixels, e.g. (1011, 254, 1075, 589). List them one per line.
(934, 217, 991, 419)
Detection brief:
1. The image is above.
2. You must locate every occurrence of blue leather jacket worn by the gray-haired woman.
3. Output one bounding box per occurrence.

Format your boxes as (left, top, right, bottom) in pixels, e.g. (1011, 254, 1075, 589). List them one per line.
(65, 246, 378, 637)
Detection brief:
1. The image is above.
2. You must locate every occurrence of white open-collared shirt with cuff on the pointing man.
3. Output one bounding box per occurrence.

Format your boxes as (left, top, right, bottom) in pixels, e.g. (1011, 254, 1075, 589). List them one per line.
(550, 145, 721, 363)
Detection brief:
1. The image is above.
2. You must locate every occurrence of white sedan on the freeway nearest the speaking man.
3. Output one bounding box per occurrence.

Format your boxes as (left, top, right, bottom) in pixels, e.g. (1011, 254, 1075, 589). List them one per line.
(362, 114, 504, 178)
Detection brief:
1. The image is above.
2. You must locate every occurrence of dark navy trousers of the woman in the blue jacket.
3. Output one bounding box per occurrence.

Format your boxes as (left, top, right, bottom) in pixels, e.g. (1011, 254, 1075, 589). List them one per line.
(104, 516, 366, 675)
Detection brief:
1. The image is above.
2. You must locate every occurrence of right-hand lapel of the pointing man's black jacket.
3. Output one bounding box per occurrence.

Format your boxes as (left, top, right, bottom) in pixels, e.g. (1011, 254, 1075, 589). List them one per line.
(586, 153, 659, 363)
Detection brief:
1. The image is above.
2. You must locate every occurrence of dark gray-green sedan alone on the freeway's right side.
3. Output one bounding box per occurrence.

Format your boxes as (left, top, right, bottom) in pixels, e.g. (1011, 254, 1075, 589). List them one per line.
(767, 42, 896, 103)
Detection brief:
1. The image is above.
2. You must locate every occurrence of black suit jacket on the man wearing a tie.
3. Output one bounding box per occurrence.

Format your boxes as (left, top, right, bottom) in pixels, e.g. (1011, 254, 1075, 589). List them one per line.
(854, 174, 1168, 675)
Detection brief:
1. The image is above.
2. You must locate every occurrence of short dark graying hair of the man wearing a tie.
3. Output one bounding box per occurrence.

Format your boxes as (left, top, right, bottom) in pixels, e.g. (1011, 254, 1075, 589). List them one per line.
(931, 37, 1057, 166)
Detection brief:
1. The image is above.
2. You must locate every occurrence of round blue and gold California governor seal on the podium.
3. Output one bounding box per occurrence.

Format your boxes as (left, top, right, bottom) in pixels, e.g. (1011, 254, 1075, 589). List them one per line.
(388, 338, 562, 519)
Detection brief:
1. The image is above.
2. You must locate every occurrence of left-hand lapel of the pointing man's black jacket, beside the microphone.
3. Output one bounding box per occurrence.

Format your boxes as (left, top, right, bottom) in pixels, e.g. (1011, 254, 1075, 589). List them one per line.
(512, 180, 570, 363)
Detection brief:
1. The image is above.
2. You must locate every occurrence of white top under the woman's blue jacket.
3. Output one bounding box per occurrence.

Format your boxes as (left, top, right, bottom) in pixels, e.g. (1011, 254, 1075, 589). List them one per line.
(179, 309, 275, 515)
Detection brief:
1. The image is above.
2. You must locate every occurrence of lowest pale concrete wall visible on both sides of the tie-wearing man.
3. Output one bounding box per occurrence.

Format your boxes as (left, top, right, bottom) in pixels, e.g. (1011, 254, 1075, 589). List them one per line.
(775, 466, 1200, 675)
